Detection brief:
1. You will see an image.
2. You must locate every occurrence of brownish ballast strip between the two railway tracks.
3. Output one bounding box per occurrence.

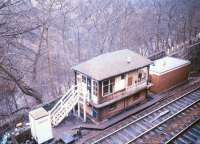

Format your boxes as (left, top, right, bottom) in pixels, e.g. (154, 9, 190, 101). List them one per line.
(131, 98, 200, 144)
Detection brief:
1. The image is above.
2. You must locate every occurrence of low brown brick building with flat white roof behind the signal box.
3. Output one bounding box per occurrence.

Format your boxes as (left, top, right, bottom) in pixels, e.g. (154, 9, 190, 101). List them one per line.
(149, 56, 190, 93)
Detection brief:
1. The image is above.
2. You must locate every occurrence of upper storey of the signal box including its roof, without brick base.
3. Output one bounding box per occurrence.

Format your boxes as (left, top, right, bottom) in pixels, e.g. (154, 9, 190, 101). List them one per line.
(73, 50, 151, 107)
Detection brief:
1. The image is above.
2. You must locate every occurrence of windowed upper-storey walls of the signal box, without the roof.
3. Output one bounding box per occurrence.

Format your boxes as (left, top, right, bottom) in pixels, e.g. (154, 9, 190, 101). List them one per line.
(76, 67, 149, 107)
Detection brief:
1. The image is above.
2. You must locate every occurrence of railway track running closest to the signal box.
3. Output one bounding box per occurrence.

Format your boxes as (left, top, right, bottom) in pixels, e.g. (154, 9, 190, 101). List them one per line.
(92, 89, 200, 144)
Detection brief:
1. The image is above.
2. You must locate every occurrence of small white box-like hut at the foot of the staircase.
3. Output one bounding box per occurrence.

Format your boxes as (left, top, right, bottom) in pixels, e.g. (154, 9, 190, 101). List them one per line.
(29, 107, 53, 144)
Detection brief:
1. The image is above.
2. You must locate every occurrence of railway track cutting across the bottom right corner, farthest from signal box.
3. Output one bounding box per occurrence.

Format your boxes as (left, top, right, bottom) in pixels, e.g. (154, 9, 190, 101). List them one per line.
(166, 117, 200, 144)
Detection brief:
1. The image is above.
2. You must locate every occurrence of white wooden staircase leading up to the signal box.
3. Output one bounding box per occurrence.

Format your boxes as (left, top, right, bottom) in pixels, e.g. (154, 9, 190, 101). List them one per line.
(49, 85, 80, 126)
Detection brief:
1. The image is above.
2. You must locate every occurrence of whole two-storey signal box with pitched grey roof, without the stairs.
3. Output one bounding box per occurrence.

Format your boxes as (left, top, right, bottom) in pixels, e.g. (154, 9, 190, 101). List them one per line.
(72, 49, 152, 121)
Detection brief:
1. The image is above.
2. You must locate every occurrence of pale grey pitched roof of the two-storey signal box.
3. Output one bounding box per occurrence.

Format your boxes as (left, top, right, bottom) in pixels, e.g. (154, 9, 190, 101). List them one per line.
(72, 49, 152, 80)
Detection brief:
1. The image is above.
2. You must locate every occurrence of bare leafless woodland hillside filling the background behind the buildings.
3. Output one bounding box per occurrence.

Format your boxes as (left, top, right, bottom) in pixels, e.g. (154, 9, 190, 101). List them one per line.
(0, 0, 200, 119)
